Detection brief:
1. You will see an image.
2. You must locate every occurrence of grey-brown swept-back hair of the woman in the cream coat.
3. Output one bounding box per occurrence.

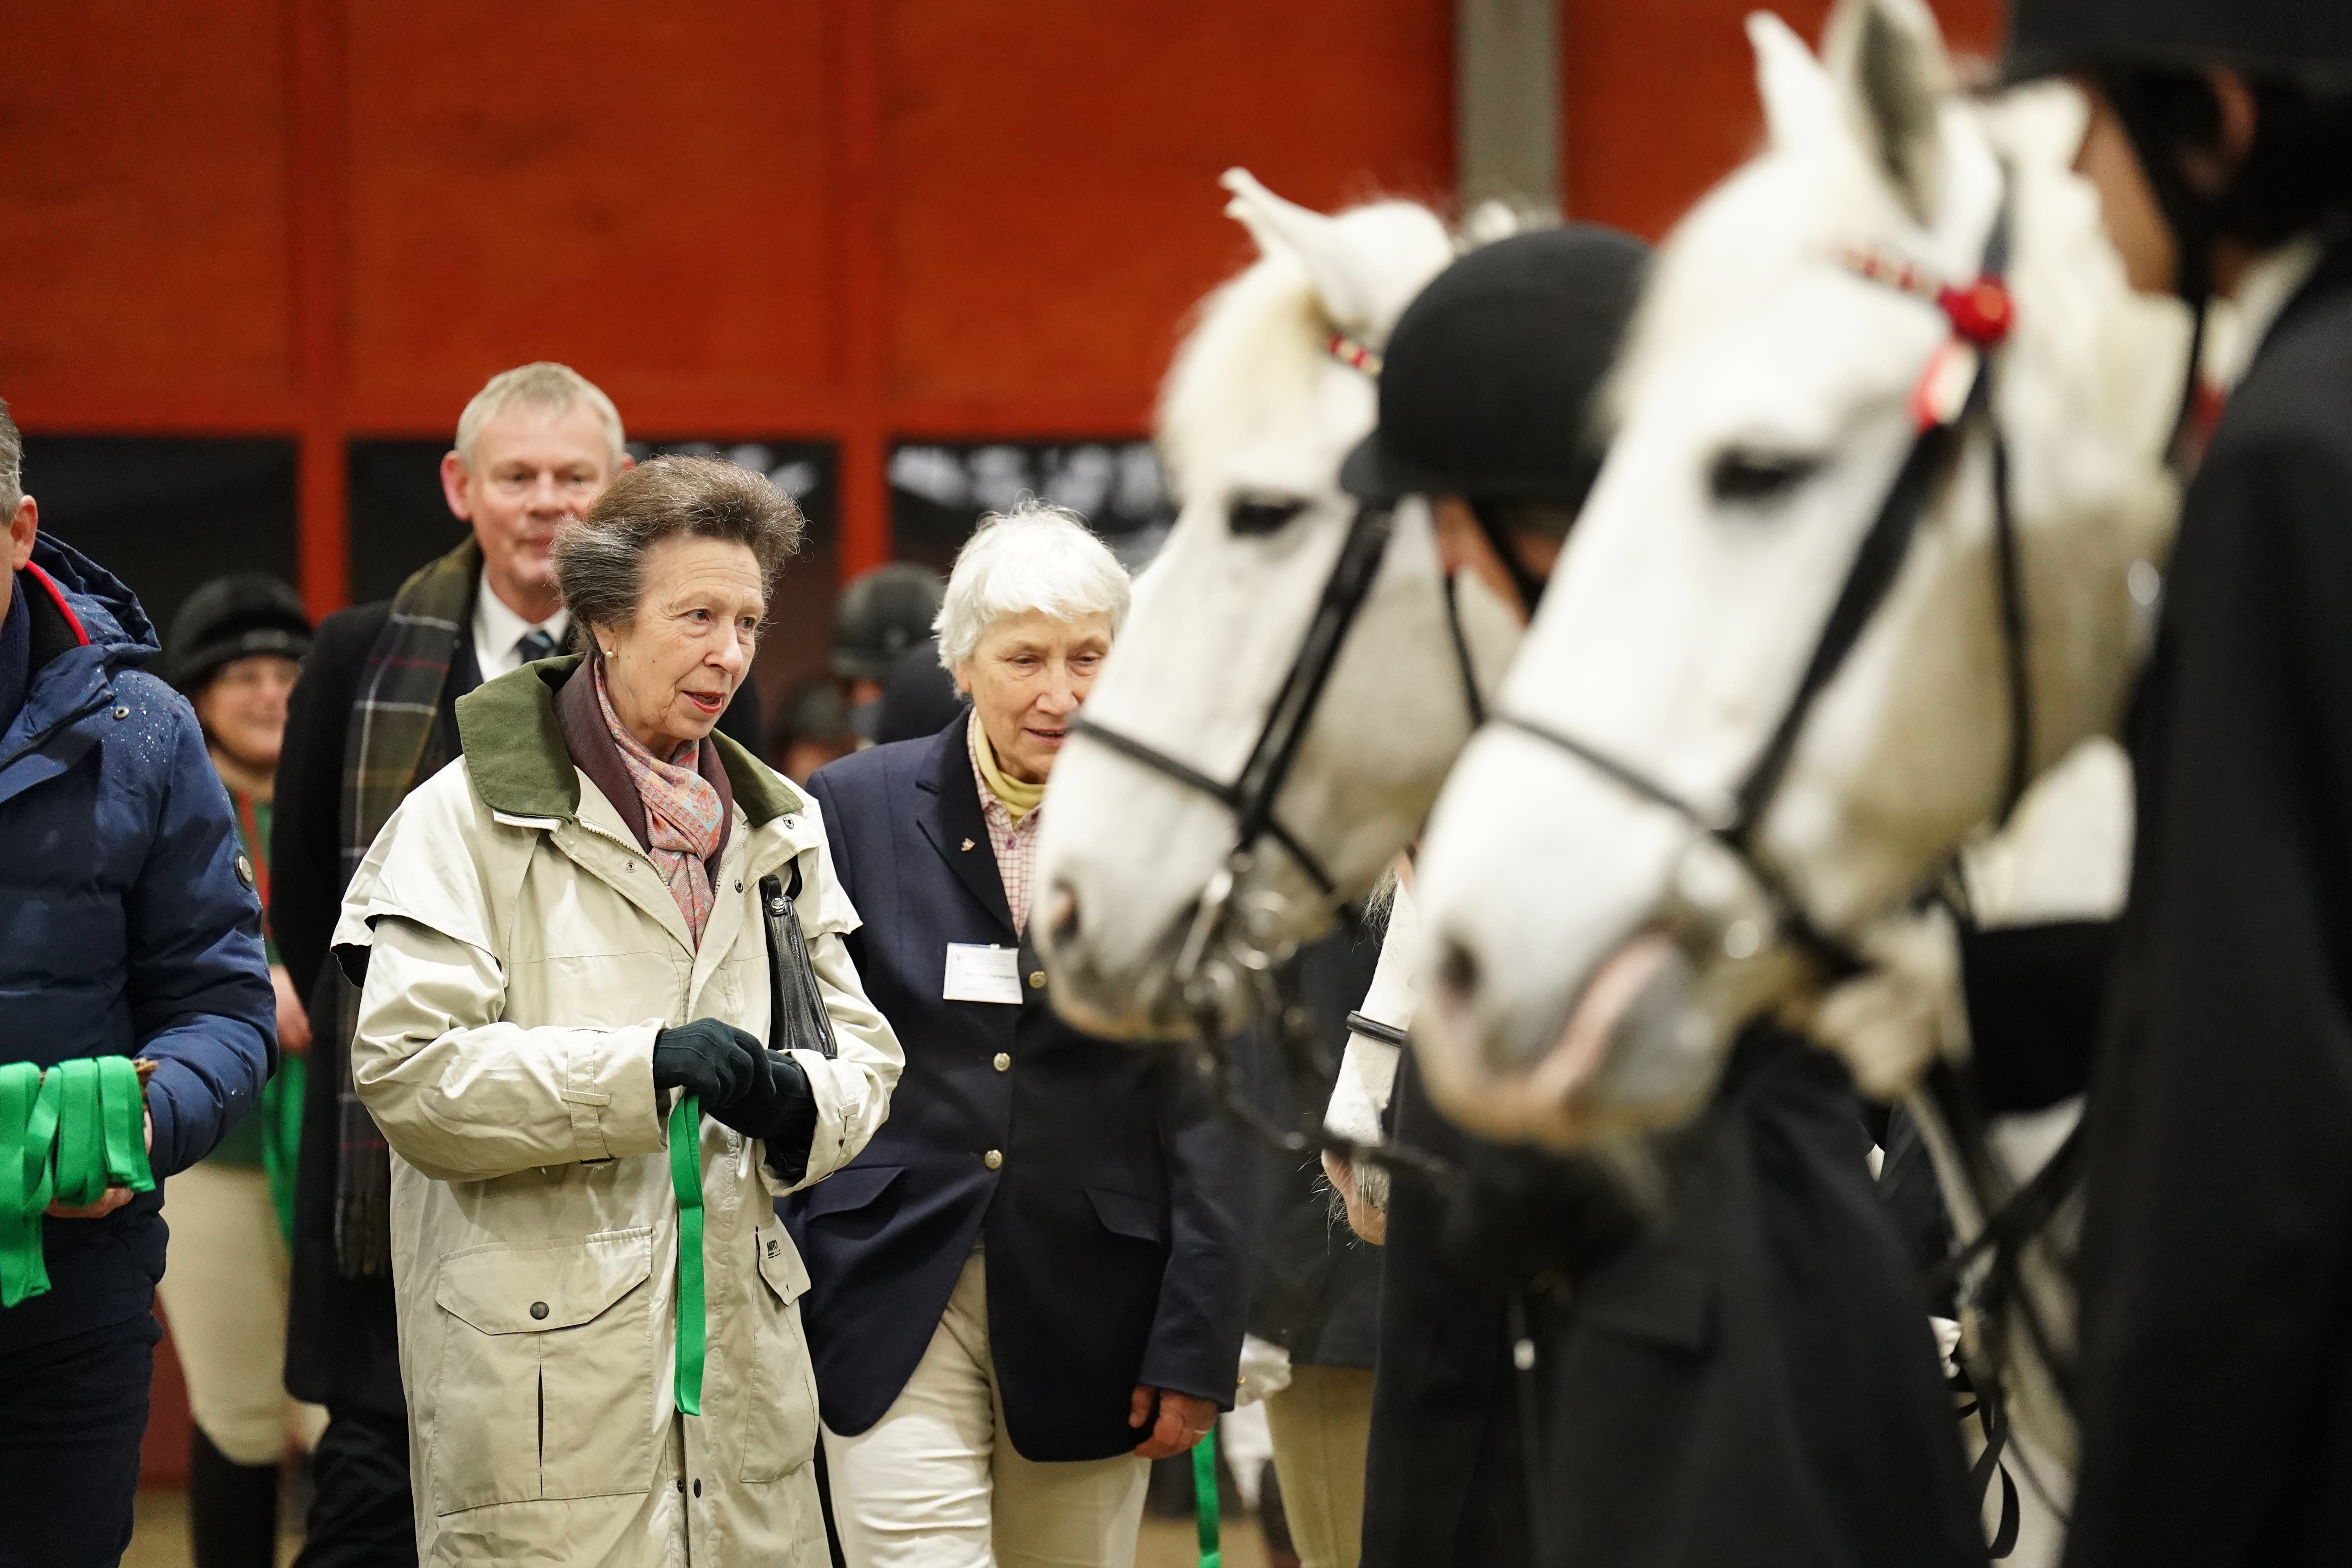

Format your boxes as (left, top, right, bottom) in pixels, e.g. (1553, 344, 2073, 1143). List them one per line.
(555, 458, 807, 646)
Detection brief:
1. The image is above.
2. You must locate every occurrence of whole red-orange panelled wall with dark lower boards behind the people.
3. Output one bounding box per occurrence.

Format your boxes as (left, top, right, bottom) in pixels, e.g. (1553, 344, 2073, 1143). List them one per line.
(0, 0, 1999, 1481)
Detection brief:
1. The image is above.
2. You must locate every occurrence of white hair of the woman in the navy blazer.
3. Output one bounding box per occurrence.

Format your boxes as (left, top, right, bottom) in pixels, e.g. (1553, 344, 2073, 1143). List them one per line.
(931, 498, 1129, 670)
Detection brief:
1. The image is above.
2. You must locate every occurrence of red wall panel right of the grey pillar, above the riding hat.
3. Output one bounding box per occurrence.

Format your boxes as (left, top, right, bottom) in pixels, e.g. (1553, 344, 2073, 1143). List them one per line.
(1559, 0, 2006, 240)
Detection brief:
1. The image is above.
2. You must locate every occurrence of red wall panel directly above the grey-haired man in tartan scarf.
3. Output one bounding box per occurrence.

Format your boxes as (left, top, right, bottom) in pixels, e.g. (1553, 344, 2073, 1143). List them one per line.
(346, 0, 840, 432)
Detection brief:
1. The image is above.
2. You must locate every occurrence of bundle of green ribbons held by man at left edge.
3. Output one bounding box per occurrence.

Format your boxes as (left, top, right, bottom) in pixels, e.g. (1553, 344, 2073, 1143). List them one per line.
(0, 1056, 155, 1307)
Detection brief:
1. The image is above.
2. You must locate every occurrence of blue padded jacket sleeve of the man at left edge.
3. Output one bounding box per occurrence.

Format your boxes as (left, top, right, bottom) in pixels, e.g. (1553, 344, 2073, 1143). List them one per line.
(125, 705, 278, 1176)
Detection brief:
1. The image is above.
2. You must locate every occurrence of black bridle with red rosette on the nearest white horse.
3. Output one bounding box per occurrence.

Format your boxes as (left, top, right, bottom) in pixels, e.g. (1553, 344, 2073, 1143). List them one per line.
(1494, 198, 2032, 980)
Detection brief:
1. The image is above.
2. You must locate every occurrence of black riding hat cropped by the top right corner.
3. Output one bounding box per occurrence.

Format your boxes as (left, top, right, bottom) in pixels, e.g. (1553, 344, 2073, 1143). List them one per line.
(2002, 0, 2352, 87)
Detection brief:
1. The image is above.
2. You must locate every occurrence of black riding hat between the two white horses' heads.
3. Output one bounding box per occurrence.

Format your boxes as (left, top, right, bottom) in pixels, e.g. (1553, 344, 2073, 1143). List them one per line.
(1338, 223, 1649, 505)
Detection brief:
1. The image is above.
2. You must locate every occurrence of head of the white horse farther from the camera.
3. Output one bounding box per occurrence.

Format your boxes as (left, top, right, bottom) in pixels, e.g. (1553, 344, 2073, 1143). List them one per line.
(1037, 172, 1515, 1034)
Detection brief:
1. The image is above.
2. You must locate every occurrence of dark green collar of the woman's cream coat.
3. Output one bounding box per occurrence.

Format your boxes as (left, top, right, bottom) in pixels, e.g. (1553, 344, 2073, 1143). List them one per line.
(456, 653, 807, 828)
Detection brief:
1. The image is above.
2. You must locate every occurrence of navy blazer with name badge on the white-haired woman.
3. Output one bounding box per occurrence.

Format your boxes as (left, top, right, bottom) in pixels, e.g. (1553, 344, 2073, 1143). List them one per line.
(783, 715, 1256, 1460)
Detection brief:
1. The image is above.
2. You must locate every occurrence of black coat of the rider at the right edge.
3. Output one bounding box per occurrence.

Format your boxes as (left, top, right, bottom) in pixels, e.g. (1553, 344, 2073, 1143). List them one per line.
(2067, 245, 2352, 1568)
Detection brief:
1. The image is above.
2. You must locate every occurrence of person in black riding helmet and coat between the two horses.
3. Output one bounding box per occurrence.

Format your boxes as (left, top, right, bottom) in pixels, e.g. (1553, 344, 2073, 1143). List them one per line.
(1341, 217, 1985, 1568)
